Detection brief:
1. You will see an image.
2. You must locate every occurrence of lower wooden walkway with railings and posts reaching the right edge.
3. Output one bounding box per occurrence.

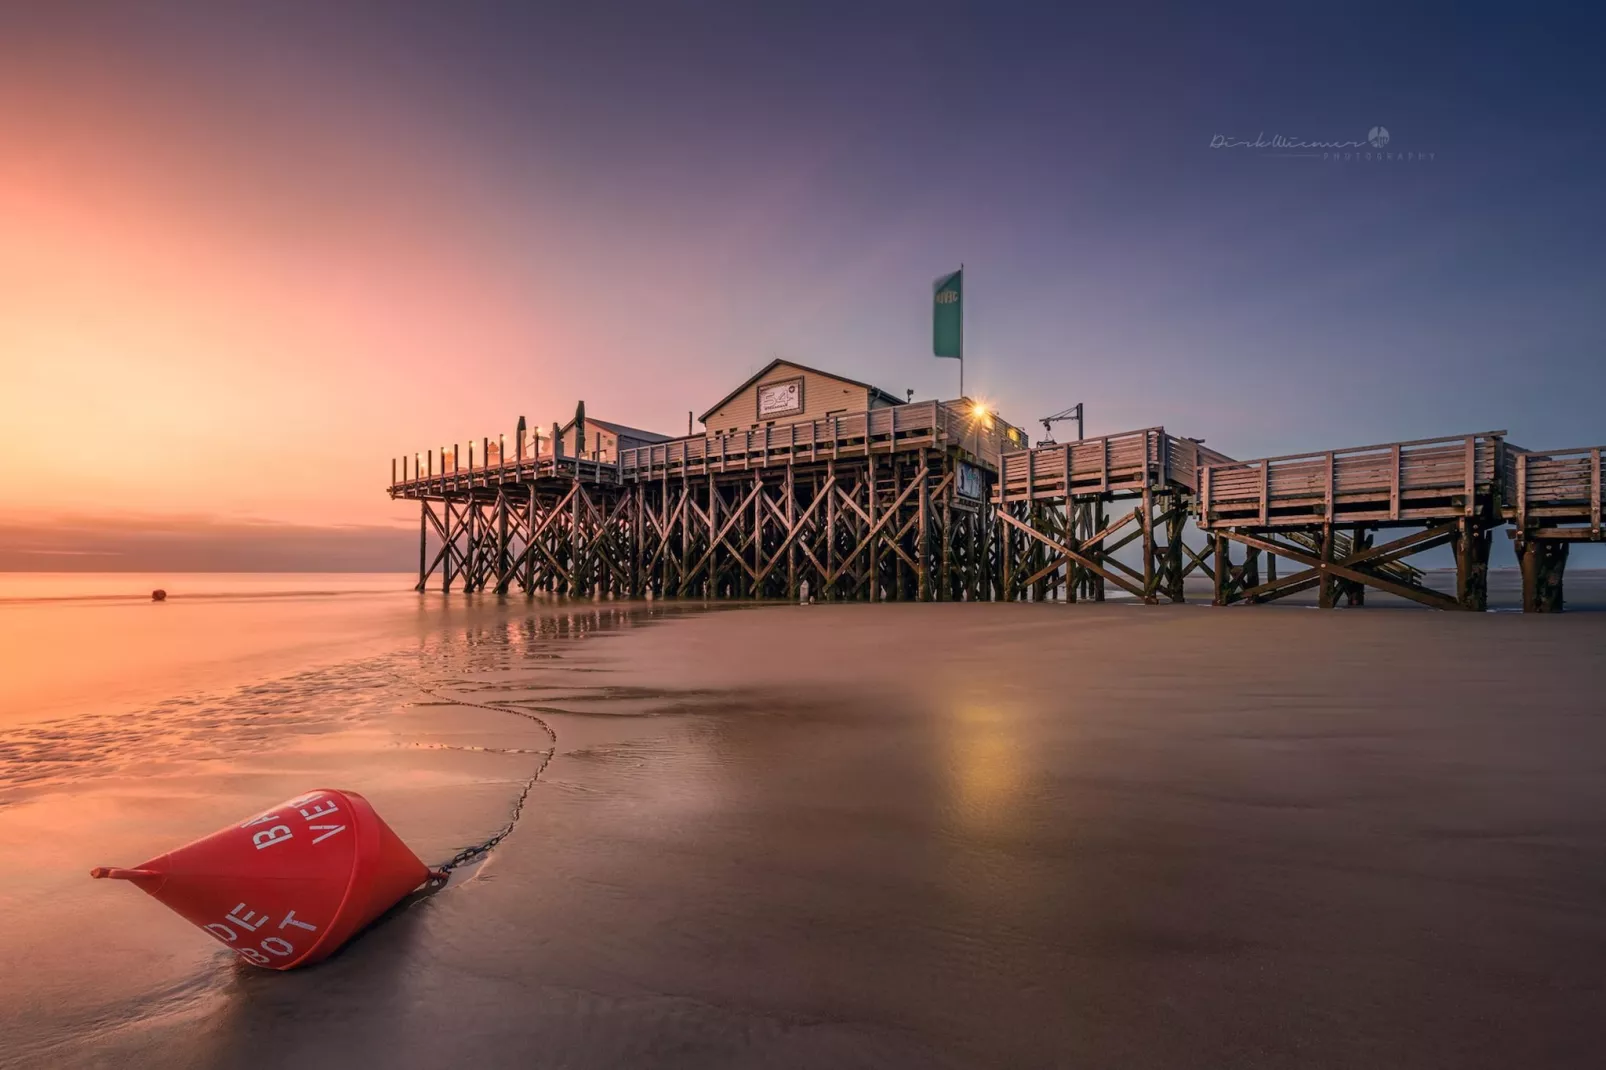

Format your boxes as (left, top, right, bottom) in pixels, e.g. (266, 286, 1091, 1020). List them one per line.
(1198, 431, 1603, 612)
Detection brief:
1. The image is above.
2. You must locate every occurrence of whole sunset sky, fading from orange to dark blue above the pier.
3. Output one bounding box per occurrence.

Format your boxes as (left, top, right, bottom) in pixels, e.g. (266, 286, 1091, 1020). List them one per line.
(0, 3, 1606, 569)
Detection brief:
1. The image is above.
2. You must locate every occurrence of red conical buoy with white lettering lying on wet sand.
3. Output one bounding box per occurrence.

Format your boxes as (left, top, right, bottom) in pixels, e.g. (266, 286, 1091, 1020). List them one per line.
(90, 787, 440, 970)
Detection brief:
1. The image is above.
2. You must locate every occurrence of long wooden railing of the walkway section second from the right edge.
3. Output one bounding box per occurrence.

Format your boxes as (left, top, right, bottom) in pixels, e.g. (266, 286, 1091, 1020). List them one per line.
(1198, 431, 1521, 530)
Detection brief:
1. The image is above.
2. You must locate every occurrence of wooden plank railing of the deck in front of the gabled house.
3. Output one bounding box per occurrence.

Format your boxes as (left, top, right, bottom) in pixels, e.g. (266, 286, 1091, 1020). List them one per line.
(618, 402, 1009, 482)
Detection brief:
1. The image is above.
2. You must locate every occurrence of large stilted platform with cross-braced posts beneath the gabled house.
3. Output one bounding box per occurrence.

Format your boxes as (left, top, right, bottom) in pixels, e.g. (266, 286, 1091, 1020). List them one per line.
(390, 402, 1018, 601)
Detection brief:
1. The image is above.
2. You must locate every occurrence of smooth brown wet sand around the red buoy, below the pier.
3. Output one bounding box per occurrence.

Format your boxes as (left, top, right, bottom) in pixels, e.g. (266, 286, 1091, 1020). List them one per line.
(0, 602, 1606, 1067)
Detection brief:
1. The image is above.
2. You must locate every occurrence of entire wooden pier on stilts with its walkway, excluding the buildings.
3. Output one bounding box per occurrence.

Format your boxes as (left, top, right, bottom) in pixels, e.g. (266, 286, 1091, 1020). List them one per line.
(390, 370, 1606, 612)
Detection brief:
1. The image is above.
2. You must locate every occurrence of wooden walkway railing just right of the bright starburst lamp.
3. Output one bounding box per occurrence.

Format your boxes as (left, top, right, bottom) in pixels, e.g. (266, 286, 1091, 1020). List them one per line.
(993, 427, 1232, 501)
